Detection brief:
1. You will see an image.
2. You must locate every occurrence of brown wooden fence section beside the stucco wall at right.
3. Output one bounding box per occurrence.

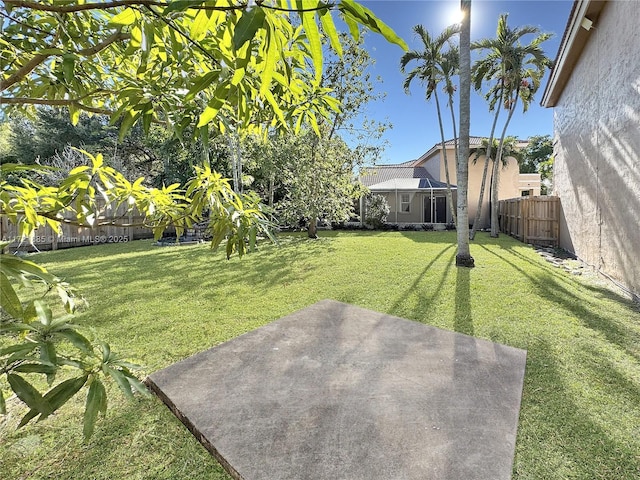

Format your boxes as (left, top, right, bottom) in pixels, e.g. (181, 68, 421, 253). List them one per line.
(498, 196, 560, 247)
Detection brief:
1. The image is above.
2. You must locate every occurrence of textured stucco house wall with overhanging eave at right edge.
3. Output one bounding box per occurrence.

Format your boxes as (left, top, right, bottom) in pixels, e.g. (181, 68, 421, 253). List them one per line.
(542, 0, 640, 298)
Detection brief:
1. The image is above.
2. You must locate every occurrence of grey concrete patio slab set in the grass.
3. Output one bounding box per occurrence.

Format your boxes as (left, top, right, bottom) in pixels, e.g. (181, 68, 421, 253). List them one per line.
(147, 300, 526, 480)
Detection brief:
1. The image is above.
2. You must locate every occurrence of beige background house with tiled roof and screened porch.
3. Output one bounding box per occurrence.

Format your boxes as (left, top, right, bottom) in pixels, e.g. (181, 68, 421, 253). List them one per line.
(360, 137, 540, 227)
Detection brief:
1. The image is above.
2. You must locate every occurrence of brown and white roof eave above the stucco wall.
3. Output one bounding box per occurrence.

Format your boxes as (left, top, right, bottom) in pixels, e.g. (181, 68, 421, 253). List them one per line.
(540, 0, 607, 108)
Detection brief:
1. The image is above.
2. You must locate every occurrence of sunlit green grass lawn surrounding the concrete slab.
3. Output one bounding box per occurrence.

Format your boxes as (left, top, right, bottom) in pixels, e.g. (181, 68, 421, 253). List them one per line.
(0, 232, 640, 480)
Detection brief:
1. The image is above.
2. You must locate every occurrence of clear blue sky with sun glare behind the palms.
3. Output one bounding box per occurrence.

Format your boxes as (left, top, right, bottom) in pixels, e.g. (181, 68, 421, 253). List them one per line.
(352, 0, 573, 164)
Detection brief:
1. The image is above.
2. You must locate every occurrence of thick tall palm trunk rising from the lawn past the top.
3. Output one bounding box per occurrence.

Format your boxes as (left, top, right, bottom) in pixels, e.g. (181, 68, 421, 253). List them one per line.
(456, 0, 474, 267)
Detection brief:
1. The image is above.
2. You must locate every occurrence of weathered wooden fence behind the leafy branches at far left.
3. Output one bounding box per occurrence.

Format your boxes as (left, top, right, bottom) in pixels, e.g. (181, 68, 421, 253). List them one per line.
(0, 201, 175, 251)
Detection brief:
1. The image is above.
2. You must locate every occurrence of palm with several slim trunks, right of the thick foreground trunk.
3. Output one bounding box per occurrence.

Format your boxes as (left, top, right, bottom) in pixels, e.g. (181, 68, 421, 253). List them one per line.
(471, 14, 551, 237)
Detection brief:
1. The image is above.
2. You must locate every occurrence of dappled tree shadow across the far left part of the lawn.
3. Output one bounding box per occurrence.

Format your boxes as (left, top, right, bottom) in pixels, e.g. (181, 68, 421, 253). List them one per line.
(51, 238, 334, 305)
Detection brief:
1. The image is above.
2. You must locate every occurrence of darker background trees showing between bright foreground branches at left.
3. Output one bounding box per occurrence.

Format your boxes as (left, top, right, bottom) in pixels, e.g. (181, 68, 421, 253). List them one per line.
(0, 107, 200, 187)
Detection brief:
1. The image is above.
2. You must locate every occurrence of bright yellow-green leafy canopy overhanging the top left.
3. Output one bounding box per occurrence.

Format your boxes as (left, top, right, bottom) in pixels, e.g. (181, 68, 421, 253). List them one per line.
(0, 0, 406, 141)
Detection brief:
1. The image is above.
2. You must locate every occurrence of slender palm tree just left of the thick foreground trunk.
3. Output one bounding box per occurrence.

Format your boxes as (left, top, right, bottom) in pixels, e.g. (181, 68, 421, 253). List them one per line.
(400, 25, 460, 222)
